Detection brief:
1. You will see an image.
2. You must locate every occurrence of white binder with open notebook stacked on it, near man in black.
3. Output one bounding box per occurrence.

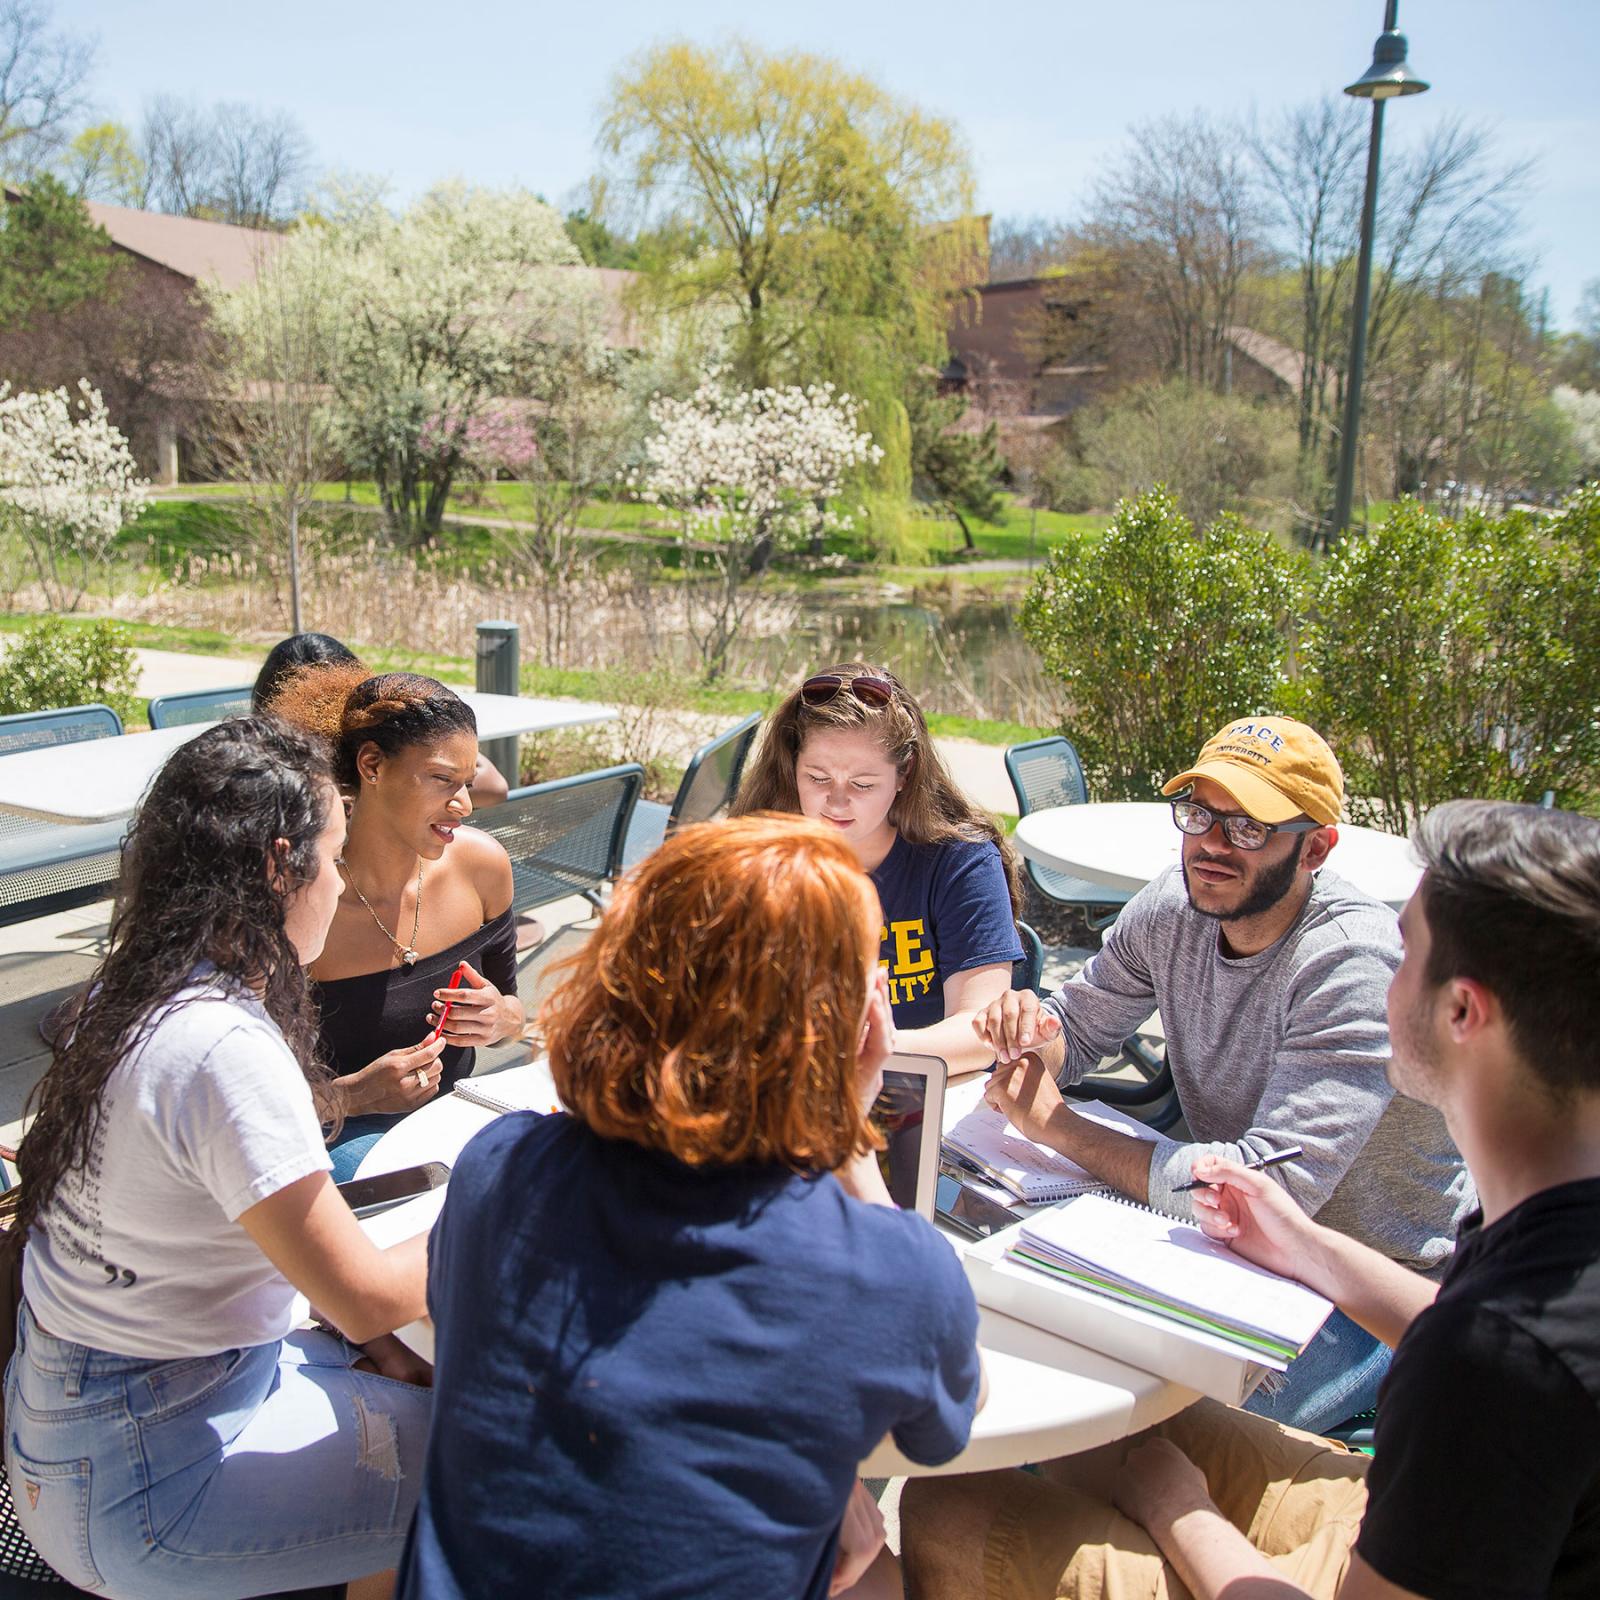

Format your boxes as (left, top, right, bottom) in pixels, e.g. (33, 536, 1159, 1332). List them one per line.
(965, 1194, 1333, 1405)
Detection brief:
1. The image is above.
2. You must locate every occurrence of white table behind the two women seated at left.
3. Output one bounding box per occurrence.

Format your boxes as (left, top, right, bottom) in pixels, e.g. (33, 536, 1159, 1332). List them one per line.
(0, 690, 616, 822)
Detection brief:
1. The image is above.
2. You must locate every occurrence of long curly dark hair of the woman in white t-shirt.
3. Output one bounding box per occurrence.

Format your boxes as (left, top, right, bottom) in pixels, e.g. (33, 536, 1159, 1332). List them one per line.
(14, 717, 339, 1238)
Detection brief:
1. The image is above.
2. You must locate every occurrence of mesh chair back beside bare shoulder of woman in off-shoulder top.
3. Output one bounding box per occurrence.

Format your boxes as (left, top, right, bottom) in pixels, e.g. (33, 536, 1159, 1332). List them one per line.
(470, 762, 645, 912)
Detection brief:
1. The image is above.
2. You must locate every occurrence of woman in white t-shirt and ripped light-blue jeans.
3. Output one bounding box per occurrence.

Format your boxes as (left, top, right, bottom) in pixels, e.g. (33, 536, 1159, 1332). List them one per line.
(5, 718, 430, 1600)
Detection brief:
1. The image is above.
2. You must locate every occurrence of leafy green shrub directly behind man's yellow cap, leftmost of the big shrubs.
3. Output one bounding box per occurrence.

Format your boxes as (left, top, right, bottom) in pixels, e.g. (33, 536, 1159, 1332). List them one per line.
(1021, 490, 1301, 798)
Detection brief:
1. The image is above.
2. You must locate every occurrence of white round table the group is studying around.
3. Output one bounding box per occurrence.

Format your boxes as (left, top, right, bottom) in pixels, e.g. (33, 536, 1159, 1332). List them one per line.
(357, 1058, 1200, 1478)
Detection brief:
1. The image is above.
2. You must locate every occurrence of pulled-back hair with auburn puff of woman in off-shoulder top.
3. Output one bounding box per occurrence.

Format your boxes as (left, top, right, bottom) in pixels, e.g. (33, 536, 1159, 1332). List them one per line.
(267, 661, 478, 795)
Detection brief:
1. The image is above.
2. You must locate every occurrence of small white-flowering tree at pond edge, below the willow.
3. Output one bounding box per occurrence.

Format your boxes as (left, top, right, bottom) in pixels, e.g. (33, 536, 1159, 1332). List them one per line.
(634, 373, 883, 680)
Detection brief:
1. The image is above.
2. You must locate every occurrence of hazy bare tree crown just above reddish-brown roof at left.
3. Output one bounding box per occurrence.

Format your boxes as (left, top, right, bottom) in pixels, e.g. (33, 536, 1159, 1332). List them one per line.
(139, 94, 310, 227)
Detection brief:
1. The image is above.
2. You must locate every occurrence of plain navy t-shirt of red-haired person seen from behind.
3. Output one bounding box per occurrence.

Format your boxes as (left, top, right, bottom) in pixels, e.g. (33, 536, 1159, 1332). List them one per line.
(400, 1114, 979, 1600)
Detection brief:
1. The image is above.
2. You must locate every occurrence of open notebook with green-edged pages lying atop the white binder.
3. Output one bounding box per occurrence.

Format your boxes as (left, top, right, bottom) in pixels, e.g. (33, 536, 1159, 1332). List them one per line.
(1006, 1195, 1333, 1365)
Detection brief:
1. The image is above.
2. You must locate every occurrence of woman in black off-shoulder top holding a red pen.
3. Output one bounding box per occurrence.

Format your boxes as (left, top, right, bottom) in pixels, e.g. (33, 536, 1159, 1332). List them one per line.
(269, 662, 525, 1182)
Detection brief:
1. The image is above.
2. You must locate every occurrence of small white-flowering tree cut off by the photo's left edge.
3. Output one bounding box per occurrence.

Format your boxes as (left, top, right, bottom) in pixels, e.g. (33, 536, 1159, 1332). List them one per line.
(0, 379, 149, 611)
